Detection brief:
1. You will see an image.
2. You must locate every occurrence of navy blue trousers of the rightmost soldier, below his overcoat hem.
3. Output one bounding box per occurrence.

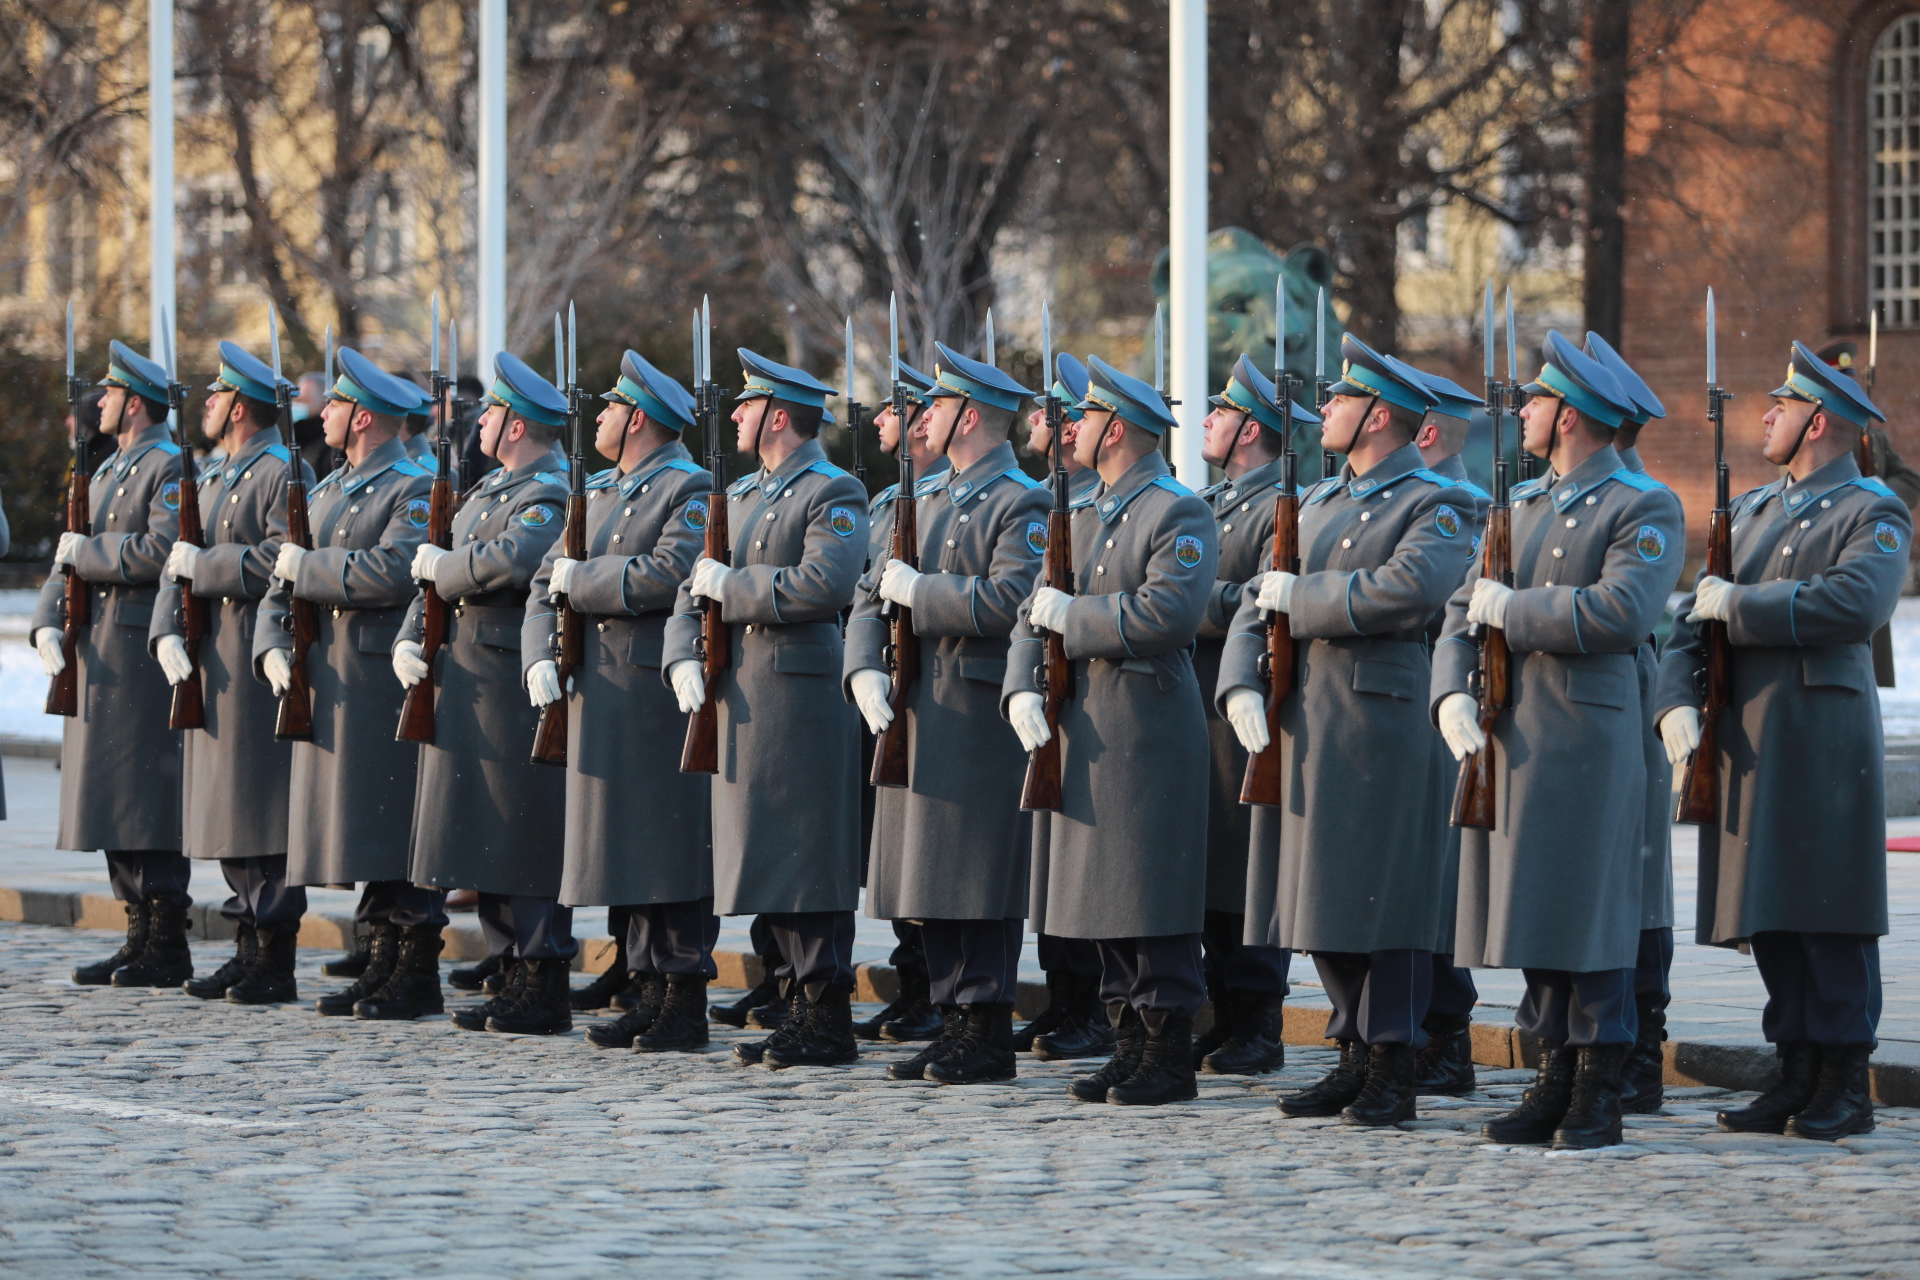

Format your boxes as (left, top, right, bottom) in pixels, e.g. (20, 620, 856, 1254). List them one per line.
(1747, 931, 1880, 1044)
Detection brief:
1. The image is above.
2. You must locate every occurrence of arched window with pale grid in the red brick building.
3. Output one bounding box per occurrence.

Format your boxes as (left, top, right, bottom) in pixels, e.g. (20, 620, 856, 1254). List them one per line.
(1866, 13, 1920, 328)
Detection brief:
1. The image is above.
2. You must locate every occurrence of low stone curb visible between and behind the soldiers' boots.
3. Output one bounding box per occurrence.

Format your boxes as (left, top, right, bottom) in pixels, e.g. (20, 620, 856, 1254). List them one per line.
(0, 887, 1920, 1107)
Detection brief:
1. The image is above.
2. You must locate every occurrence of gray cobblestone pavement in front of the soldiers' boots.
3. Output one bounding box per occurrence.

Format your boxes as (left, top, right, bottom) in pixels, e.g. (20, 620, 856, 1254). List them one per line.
(0, 923, 1920, 1280)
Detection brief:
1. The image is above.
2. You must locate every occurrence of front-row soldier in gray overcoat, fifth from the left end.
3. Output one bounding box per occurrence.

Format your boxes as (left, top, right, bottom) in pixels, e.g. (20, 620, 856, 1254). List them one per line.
(520, 351, 716, 1052)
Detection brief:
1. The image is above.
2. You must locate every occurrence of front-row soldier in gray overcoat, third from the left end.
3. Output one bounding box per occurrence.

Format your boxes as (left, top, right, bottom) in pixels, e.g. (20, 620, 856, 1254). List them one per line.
(253, 347, 447, 1017)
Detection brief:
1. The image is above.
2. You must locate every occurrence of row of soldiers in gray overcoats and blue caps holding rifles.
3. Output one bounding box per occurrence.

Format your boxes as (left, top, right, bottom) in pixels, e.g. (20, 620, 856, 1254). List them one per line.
(35, 307, 1910, 1148)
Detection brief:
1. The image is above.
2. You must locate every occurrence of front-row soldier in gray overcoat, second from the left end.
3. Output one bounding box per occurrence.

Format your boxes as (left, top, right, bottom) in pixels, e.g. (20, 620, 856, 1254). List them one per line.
(148, 342, 311, 1004)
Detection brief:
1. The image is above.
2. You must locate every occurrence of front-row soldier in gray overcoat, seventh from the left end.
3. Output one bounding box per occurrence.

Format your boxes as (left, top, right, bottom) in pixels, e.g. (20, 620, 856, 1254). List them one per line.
(843, 344, 1046, 1084)
